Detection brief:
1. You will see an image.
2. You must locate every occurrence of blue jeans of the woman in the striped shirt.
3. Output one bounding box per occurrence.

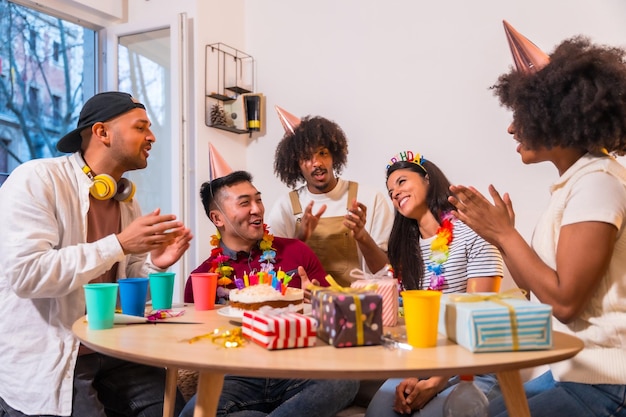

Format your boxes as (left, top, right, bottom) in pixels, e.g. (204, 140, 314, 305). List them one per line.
(365, 374, 500, 417)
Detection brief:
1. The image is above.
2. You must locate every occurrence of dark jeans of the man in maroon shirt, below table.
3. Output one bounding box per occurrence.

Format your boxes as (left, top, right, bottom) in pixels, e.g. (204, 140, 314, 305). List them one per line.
(179, 375, 359, 417)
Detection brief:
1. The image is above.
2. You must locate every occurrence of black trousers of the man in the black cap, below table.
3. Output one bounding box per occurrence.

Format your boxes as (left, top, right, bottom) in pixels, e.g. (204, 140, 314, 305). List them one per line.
(0, 353, 185, 417)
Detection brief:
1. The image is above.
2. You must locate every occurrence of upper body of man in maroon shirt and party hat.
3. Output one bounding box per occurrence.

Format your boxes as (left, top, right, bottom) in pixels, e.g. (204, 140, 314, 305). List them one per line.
(184, 144, 328, 304)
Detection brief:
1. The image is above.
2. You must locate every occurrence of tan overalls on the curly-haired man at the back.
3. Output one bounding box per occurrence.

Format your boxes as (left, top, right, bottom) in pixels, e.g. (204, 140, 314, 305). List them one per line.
(289, 181, 361, 287)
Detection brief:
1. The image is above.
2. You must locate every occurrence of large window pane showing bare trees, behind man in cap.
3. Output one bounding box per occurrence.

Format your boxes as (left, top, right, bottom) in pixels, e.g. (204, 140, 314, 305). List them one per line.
(0, 0, 97, 185)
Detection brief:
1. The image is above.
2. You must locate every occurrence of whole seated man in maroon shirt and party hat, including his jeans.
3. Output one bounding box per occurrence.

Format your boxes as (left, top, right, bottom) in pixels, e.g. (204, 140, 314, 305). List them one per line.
(180, 148, 359, 417)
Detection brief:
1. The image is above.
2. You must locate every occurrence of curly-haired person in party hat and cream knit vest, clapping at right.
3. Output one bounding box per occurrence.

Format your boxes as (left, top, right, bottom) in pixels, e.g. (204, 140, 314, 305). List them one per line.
(449, 22, 626, 417)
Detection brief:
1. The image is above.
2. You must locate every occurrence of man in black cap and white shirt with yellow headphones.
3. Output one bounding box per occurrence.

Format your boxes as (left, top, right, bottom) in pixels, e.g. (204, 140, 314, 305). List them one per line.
(0, 92, 192, 417)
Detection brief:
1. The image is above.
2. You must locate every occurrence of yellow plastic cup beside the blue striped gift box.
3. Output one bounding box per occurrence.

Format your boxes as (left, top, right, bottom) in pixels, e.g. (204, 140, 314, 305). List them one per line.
(400, 290, 441, 348)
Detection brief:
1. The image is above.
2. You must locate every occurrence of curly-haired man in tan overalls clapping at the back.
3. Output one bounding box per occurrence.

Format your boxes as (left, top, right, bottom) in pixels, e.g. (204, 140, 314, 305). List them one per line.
(269, 114, 393, 286)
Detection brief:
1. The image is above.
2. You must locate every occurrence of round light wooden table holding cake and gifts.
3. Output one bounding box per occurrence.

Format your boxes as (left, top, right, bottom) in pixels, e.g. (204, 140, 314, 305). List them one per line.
(72, 305, 583, 417)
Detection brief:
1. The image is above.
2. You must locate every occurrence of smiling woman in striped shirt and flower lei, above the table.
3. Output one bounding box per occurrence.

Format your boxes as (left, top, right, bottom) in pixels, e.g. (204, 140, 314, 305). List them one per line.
(387, 151, 503, 293)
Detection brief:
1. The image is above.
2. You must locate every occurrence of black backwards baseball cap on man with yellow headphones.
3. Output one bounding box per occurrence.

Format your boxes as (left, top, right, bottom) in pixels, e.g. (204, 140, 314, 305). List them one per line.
(57, 91, 146, 153)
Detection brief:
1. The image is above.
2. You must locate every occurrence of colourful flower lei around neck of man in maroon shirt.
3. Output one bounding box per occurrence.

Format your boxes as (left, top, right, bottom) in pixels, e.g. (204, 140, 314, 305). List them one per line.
(209, 224, 276, 286)
